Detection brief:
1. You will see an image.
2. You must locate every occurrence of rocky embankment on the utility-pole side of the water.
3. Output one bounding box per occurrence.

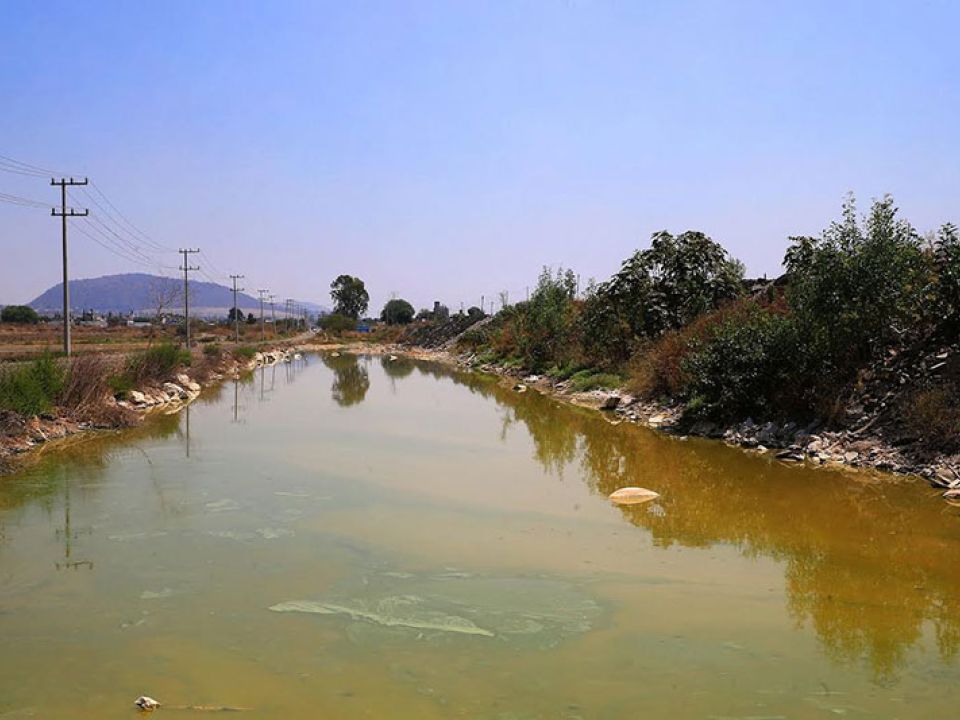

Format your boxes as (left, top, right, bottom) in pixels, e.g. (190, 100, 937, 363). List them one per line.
(0, 347, 299, 471)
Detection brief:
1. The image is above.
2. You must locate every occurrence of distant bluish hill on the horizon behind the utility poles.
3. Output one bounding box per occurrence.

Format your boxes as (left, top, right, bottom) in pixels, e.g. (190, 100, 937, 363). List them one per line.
(28, 273, 323, 315)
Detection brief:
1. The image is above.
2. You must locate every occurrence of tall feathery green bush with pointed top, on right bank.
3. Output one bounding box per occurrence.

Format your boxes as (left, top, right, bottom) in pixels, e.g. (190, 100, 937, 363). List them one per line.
(784, 196, 933, 379)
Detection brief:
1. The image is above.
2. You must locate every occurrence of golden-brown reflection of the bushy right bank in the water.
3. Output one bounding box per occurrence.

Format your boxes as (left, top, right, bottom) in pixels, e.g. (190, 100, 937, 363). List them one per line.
(414, 365, 960, 682)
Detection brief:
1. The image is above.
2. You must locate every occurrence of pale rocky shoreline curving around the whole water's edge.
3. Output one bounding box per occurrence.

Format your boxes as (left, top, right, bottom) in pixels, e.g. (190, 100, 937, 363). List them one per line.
(0, 338, 960, 506)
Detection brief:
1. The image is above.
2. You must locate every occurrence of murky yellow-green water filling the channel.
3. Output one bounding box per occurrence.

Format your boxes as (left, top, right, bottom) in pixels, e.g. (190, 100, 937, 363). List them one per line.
(0, 357, 960, 720)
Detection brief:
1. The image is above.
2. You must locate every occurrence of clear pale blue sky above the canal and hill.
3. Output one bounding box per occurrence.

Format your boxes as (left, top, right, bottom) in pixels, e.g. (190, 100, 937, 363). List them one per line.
(0, 0, 960, 313)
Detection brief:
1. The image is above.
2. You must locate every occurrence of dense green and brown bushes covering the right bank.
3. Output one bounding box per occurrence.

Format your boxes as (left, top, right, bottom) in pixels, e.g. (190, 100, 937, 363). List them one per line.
(462, 196, 960, 435)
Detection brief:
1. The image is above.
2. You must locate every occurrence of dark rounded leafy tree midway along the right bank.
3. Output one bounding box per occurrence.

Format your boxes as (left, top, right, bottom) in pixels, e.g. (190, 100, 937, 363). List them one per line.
(583, 230, 743, 365)
